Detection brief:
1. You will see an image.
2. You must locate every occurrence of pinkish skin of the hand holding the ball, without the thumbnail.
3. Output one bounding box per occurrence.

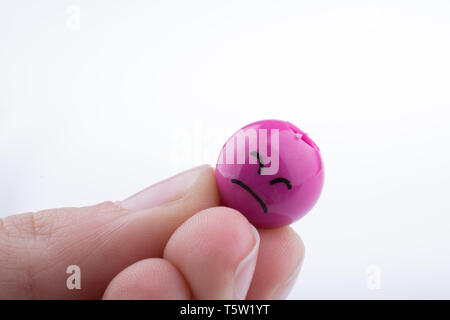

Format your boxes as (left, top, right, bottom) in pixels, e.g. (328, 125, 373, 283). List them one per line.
(0, 167, 304, 299)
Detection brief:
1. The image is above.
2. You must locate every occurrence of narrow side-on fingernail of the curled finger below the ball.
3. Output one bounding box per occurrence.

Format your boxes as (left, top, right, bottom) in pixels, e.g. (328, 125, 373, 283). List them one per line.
(233, 222, 259, 300)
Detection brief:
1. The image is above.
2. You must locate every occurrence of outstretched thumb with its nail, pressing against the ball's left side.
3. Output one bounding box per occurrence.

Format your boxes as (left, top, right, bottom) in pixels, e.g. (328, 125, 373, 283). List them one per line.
(0, 166, 219, 299)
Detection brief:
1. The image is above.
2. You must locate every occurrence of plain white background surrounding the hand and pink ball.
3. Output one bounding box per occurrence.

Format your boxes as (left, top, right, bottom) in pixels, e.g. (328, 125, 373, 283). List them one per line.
(0, 0, 450, 299)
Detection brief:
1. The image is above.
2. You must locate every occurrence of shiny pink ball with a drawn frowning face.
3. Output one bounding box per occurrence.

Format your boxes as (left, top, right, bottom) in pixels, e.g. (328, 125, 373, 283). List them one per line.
(216, 120, 324, 228)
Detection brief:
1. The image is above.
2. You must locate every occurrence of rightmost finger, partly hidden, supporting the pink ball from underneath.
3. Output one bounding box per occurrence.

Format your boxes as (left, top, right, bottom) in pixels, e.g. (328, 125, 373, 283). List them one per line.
(247, 227, 305, 300)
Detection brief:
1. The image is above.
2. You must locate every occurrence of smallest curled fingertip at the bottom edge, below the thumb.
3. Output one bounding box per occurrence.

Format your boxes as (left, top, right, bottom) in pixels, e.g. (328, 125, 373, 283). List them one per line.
(103, 258, 191, 300)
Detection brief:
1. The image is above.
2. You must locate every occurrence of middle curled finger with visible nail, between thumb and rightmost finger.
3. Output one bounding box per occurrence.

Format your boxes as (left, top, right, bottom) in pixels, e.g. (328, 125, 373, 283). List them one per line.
(164, 207, 259, 299)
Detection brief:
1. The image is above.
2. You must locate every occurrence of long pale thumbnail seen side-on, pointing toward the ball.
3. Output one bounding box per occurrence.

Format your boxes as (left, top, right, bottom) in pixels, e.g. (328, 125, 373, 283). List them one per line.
(118, 165, 209, 210)
